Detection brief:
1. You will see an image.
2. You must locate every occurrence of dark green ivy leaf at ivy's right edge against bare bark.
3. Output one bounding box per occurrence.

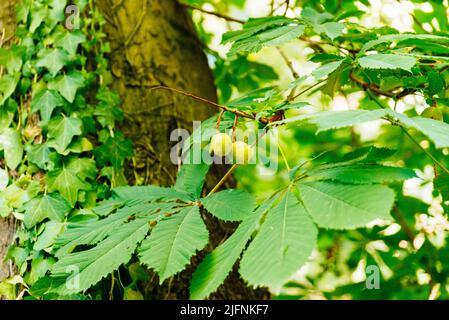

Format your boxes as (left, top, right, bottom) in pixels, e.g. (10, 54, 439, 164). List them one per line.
(94, 132, 134, 169)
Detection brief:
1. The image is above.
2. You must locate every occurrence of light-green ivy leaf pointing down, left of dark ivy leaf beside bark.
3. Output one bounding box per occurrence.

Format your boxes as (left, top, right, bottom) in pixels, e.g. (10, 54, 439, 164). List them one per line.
(48, 116, 83, 154)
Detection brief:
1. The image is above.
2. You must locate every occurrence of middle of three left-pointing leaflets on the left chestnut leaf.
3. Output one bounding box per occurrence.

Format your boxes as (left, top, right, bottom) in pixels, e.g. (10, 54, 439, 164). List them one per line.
(55, 201, 175, 258)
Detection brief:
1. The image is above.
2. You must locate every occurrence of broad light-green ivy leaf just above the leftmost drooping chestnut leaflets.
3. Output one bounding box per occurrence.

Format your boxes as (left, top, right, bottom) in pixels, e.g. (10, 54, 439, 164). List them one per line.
(23, 193, 72, 229)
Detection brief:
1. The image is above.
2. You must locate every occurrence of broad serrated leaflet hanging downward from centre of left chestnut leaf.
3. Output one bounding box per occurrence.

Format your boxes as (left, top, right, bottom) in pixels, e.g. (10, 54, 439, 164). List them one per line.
(139, 206, 209, 283)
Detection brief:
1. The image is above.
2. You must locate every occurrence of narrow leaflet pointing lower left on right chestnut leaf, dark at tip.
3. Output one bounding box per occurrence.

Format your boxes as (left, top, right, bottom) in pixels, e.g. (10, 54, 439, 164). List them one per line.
(190, 197, 277, 300)
